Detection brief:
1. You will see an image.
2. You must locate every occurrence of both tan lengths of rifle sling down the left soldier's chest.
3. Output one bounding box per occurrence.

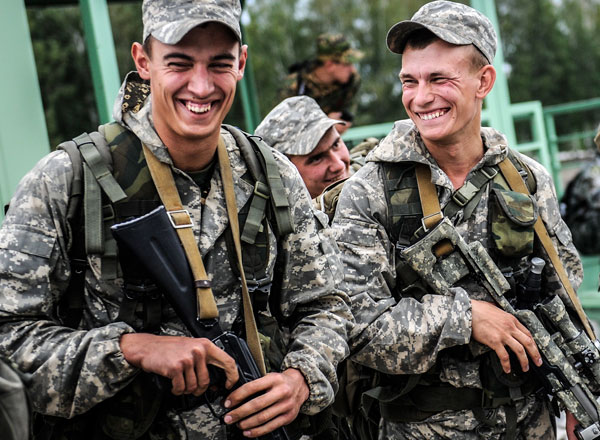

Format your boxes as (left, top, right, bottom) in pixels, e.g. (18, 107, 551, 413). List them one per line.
(142, 137, 266, 375)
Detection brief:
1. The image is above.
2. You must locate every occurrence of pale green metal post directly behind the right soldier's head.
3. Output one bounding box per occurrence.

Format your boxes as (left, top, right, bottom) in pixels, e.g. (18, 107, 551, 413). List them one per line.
(471, 0, 517, 146)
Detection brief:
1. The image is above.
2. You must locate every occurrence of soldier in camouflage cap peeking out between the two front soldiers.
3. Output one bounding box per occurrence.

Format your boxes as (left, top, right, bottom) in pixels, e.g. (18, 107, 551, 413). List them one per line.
(254, 96, 350, 198)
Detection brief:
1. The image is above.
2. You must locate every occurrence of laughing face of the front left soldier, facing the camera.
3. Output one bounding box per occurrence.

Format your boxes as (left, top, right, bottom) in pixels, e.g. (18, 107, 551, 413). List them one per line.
(134, 23, 247, 146)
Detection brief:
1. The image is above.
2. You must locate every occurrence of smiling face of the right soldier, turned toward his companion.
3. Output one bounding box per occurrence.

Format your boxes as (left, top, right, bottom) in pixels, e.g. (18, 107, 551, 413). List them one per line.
(400, 39, 495, 150)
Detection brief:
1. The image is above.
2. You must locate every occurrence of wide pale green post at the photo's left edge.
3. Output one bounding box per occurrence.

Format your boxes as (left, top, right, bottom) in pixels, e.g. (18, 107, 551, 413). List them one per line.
(0, 0, 50, 220)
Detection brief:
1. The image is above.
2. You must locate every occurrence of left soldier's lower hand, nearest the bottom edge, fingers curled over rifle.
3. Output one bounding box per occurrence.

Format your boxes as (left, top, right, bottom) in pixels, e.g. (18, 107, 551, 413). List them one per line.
(224, 368, 309, 437)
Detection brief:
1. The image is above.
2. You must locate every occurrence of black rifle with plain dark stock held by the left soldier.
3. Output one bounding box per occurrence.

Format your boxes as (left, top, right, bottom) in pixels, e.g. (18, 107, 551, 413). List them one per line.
(111, 206, 289, 440)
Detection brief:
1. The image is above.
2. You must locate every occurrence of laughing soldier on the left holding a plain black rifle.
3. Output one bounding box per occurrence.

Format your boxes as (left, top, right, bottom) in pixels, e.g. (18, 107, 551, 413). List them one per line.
(0, 0, 352, 439)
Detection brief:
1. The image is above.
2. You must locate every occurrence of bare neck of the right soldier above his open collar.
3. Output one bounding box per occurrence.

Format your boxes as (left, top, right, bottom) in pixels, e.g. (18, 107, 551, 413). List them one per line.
(425, 135, 484, 189)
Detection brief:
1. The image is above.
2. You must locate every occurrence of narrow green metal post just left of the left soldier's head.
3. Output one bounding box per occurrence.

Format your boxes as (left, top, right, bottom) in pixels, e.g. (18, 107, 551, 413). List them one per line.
(79, 0, 120, 124)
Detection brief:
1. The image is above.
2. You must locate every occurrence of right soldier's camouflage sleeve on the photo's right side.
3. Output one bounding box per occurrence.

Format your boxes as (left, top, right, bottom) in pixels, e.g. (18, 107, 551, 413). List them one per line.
(521, 155, 583, 310)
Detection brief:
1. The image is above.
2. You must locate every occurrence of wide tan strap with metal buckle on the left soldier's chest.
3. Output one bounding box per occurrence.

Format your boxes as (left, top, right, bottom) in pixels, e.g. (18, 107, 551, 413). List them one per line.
(142, 143, 219, 319)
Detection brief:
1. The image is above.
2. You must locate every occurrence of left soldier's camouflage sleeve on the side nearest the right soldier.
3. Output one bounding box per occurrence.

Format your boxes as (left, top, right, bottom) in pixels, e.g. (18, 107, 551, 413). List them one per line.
(276, 155, 353, 414)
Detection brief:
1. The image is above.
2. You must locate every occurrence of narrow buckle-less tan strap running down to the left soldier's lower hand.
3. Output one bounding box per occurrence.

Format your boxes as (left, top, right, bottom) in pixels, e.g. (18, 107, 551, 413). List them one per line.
(217, 136, 267, 376)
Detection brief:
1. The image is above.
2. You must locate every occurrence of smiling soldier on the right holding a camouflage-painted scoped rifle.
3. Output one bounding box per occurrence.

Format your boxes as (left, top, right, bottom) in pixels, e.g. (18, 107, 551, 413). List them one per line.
(332, 1, 582, 439)
